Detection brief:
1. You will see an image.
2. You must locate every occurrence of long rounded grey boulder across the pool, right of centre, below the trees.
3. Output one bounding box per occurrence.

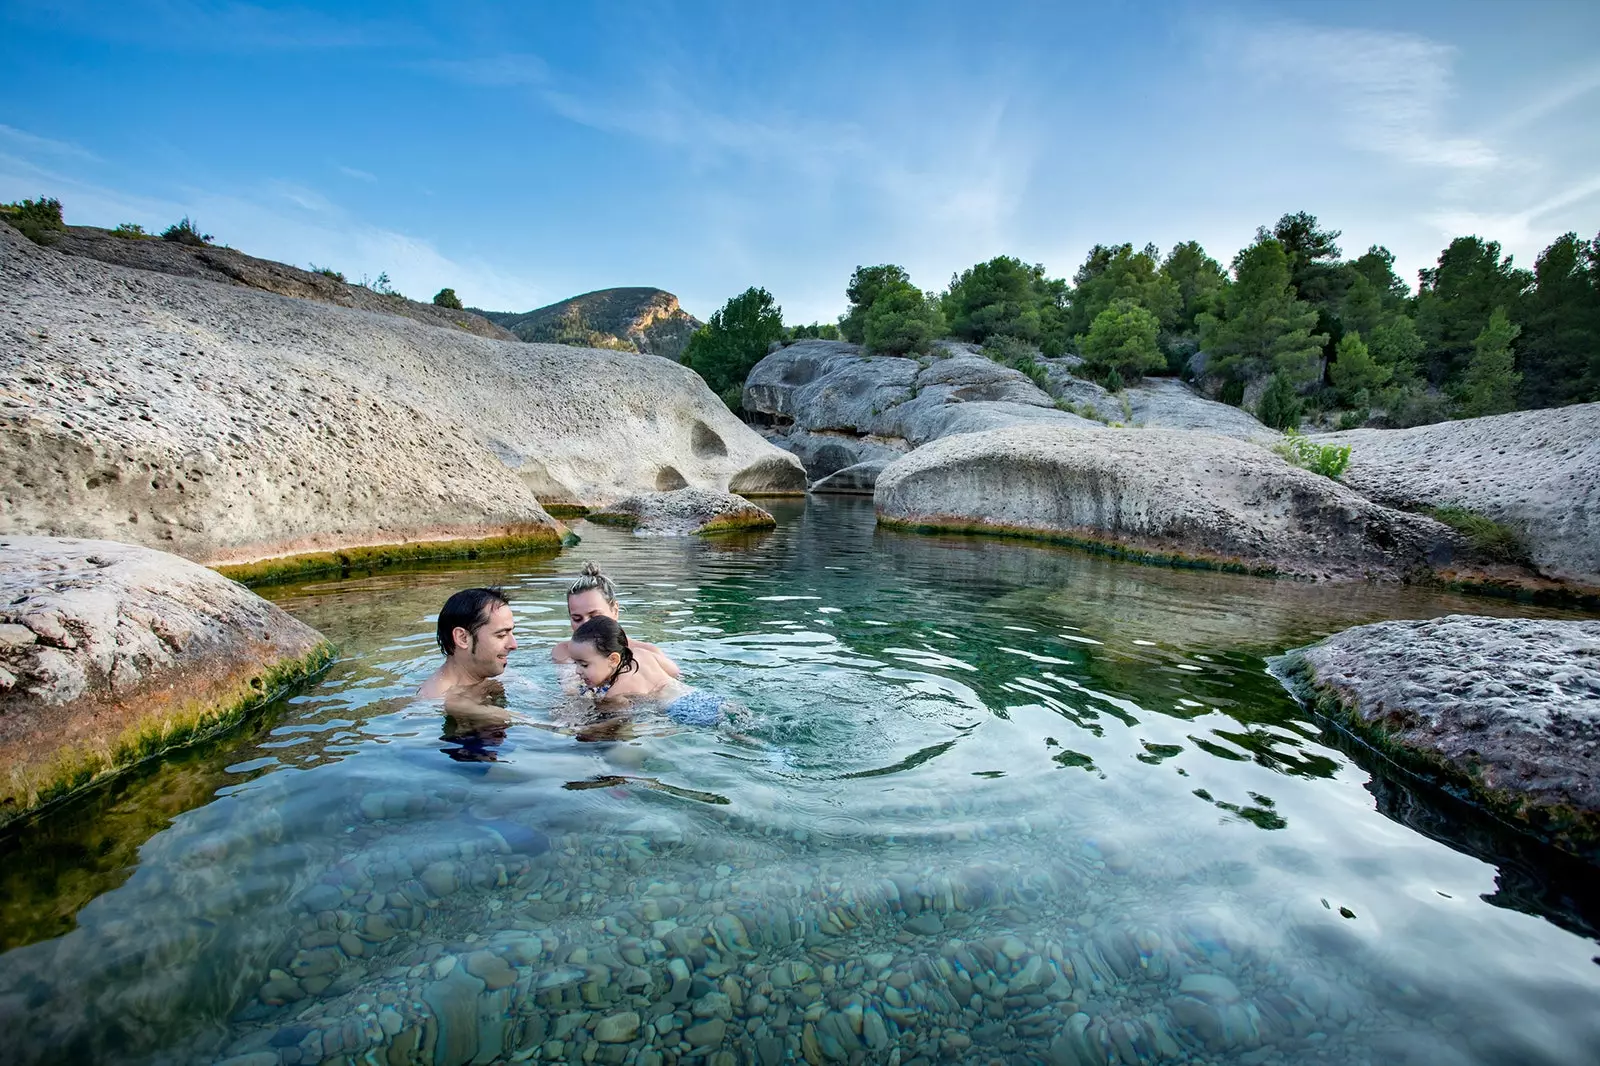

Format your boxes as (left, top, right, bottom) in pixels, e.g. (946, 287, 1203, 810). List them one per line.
(874, 424, 1456, 578)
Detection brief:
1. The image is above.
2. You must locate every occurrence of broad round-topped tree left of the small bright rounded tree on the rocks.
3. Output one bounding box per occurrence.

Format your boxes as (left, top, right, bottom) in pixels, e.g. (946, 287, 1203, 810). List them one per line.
(939, 256, 1067, 355)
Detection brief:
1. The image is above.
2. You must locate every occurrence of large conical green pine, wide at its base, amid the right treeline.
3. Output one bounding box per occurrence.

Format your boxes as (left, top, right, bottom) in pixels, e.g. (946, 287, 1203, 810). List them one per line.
(1198, 237, 1328, 386)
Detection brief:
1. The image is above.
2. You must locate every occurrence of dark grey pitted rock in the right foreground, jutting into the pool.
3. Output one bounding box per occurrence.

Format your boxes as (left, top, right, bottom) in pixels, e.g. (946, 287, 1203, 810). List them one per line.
(1275, 615, 1600, 858)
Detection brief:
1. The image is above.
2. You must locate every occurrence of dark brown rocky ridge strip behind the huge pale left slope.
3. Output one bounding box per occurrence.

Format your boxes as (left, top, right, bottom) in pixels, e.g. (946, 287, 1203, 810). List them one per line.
(40, 226, 512, 341)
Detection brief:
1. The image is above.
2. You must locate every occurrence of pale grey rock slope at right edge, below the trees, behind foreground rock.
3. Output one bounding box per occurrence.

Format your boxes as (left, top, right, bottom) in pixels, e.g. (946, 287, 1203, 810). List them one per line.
(1315, 403, 1600, 587)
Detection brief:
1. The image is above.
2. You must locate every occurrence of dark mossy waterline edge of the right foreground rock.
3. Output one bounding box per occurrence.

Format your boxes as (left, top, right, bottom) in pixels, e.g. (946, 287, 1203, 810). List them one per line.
(1269, 650, 1600, 860)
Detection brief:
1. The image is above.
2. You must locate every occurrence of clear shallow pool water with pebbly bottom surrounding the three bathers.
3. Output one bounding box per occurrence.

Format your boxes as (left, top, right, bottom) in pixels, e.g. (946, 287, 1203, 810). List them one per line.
(0, 499, 1600, 1066)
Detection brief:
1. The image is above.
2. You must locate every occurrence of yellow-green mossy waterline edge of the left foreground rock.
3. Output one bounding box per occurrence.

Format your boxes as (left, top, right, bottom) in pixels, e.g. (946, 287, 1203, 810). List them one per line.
(0, 640, 336, 831)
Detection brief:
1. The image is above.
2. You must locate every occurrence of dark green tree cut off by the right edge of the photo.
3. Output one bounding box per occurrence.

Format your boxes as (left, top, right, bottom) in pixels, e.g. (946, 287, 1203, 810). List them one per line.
(1517, 234, 1600, 407)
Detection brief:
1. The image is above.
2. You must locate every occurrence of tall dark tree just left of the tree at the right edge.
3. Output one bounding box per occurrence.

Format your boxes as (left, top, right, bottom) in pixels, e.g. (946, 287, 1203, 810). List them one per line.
(1416, 237, 1533, 389)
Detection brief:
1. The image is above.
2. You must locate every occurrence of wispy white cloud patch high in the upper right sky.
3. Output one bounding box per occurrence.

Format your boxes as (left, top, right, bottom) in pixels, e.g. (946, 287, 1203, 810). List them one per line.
(1222, 22, 1501, 170)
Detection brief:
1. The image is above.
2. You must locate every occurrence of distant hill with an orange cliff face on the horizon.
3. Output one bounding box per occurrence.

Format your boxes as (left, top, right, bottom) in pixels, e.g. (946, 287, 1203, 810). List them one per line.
(470, 288, 702, 360)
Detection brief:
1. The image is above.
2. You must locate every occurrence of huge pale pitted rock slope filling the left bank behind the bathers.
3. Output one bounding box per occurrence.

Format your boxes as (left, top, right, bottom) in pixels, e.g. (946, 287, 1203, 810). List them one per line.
(0, 226, 806, 563)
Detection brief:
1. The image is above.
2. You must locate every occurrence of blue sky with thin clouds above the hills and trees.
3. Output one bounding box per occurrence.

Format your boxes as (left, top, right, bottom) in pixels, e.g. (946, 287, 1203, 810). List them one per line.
(0, 0, 1600, 322)
